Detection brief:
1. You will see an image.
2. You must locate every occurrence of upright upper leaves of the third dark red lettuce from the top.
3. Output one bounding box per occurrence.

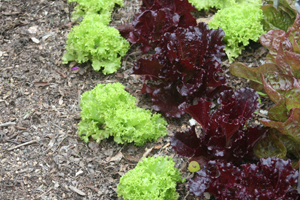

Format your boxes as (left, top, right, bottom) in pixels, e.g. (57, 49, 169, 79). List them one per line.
(186, 88, 259, 142)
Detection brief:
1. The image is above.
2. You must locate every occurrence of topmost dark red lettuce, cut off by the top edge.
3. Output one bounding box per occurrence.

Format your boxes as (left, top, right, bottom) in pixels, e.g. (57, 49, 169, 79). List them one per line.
(117, 0, 197, 52)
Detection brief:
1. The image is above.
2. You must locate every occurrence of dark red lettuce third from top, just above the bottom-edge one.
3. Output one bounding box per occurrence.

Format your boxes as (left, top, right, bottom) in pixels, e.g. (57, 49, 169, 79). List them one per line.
(171, 88, 267, 164)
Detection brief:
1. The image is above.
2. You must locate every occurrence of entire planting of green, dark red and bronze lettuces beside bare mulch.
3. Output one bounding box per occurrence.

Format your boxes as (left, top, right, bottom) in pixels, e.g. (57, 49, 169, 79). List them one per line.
(63, 0, 300, 200)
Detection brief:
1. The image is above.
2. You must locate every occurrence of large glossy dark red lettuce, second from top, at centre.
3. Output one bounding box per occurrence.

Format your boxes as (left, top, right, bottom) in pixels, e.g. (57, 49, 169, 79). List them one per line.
(132, 23, 229, 117)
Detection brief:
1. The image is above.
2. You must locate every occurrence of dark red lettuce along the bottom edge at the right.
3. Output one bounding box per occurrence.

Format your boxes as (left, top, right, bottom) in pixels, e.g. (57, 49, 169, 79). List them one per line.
(189, 158, 300, 200)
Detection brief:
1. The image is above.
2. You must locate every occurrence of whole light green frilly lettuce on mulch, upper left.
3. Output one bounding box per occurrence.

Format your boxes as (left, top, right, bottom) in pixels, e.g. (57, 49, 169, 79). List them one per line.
(62, 14, 129, 74)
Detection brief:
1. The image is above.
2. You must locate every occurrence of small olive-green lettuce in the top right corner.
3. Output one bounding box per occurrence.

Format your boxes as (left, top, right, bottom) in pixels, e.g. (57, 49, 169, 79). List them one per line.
(261, 0, 297, 31)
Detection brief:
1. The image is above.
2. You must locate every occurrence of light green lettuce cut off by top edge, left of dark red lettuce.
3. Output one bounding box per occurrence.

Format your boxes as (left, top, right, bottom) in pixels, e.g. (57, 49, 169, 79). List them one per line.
(68, 0, 124, 21)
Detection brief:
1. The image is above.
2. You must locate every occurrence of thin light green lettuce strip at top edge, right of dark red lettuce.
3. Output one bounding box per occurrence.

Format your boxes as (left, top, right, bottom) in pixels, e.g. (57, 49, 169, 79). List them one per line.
(189, 0, 261, 10)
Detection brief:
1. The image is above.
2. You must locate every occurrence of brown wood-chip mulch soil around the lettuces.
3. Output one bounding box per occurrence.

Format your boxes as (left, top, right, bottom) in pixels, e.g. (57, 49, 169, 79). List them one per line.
(0, 0, 272, 200)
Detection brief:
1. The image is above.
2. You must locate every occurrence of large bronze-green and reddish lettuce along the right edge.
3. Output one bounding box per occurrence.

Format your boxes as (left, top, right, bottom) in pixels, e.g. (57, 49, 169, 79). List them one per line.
(230, 14, 300, 162)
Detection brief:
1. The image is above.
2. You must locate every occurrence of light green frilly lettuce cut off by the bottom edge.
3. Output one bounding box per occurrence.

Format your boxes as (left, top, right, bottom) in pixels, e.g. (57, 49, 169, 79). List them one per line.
(117, 156, 185, 200)
